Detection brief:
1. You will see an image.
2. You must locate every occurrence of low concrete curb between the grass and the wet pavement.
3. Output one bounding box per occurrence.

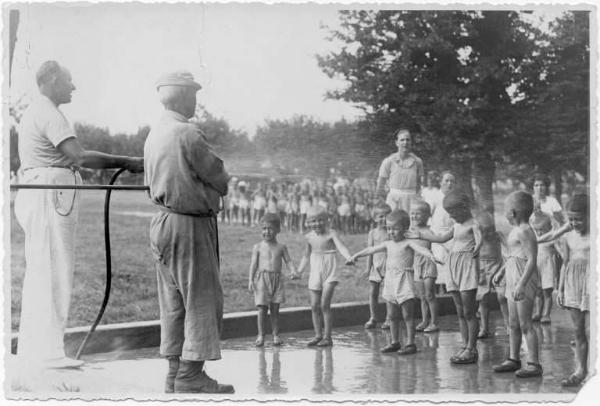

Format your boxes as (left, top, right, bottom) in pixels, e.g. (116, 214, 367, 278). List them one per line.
(11, 295, 498, 356)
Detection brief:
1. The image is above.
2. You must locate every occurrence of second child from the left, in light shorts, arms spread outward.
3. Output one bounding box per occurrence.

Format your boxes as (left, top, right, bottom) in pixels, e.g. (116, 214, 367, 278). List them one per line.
(298, 205, 350, 347)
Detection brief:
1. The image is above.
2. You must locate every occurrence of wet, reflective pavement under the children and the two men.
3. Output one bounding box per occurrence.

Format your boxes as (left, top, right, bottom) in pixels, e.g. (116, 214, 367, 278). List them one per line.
(6, 310, 578, 400)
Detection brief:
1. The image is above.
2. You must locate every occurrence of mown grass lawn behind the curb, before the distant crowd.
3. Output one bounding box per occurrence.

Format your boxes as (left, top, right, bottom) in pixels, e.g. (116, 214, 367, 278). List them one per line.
(10, 191, 368, 330)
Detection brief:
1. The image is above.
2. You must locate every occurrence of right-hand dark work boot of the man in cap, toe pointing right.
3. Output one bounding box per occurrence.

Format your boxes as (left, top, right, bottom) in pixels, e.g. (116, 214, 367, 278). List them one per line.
(175, 360, 234, 393)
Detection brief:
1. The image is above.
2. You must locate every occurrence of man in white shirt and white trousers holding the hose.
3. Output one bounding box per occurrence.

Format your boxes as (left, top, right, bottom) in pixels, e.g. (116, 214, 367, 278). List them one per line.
(15, 61, 143, 368)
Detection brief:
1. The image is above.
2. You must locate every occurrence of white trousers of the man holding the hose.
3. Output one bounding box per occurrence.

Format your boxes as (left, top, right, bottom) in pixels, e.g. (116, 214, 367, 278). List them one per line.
(15, 168, 81, 362)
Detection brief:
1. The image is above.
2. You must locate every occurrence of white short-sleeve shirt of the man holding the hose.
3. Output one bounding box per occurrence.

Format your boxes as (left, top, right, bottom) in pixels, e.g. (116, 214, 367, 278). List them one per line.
(18, 95, 75, 169)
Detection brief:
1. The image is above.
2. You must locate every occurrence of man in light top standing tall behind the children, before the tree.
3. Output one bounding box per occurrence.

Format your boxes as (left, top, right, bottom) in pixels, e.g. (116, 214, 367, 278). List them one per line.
(377, 128, 423, 212)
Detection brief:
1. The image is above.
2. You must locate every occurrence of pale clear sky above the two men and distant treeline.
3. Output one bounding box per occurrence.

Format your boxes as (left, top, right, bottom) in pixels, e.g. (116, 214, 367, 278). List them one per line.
(10, 3, 572, 136)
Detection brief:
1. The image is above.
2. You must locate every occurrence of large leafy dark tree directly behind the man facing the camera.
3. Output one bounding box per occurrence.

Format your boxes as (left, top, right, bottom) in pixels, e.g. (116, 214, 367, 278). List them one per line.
(318, 10, 540, 212)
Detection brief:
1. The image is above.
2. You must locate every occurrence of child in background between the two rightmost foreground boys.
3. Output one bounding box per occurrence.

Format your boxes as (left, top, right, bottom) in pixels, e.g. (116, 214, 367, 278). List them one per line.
(529, 211, 559, 324)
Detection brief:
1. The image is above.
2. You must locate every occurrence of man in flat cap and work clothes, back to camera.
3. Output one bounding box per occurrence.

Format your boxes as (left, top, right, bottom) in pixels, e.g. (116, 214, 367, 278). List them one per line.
(144, 71, 233, 393)
